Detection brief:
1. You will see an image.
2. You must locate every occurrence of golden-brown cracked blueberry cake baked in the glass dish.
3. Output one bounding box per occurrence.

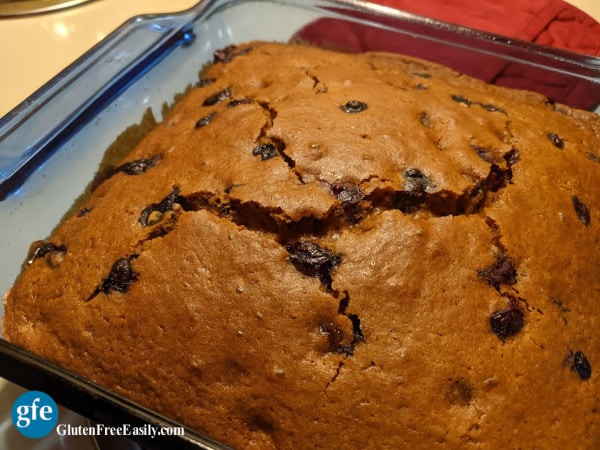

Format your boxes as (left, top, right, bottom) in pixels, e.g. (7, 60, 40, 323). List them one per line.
(3, 42, 600, 449)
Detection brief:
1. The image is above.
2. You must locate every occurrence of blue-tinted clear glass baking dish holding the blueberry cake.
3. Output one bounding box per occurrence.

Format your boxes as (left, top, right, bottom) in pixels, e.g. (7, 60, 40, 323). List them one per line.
(0, 0, 600, 448)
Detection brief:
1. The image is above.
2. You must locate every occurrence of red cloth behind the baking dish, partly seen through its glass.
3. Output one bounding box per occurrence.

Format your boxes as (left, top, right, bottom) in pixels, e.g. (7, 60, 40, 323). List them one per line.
(297, 0, 600, 109)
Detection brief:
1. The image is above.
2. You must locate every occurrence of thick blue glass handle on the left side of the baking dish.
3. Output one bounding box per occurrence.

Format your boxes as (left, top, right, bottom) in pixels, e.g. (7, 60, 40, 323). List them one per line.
(0, 11, 193, 200)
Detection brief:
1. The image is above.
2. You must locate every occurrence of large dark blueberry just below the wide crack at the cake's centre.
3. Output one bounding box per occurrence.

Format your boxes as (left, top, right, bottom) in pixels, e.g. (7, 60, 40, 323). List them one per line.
(285, 241, 342, 285)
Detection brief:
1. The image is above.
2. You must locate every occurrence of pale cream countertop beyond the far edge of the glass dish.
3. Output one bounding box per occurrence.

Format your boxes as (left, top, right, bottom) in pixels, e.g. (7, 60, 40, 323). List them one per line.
(0, 0, 600, 117)
